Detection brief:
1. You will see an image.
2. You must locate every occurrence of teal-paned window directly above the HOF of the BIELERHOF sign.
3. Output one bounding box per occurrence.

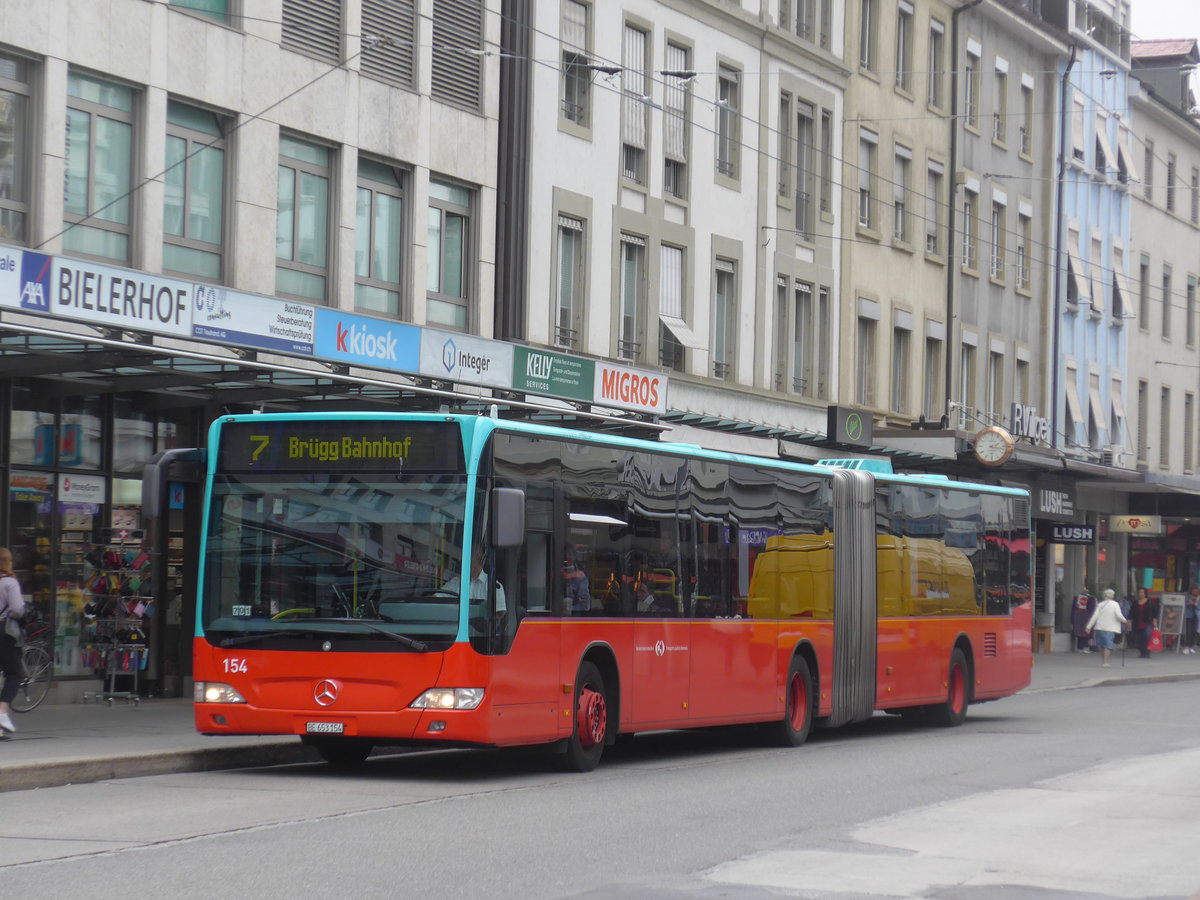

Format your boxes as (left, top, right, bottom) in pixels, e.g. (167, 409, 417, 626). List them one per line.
(162, 100, 226, 281)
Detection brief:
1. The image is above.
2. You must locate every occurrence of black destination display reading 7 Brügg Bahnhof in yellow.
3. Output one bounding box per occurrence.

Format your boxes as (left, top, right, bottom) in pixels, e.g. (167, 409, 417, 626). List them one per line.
(217, 419, 463, 473)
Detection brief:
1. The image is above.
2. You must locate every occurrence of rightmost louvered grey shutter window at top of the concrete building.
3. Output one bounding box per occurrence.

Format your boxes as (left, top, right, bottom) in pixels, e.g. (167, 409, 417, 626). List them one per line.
(430, 0, 485, 110)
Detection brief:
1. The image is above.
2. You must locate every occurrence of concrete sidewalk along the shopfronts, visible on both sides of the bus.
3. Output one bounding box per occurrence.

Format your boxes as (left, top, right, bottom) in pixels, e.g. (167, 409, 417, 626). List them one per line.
(0, 650, 1200, 791)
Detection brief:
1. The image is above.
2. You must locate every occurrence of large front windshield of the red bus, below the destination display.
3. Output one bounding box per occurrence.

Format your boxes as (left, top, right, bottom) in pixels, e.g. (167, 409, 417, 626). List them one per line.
(202, 472, 467, 650)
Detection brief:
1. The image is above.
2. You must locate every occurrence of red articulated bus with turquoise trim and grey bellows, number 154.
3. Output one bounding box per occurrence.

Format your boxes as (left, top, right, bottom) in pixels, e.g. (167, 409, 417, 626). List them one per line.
(175, 413, 1032, 772)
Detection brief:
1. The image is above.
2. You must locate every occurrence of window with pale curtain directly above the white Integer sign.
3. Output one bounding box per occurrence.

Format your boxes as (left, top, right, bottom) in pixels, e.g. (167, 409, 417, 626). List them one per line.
(425, 180, 473, 330)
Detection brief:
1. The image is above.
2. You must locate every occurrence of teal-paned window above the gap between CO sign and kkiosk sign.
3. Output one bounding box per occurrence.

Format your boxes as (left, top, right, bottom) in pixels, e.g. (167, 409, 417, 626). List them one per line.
(275, 134, 334, 300)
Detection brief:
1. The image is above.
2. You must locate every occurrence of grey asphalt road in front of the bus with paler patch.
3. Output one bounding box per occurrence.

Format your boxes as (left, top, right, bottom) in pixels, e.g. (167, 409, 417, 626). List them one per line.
(0, 683, 1200, 900)
